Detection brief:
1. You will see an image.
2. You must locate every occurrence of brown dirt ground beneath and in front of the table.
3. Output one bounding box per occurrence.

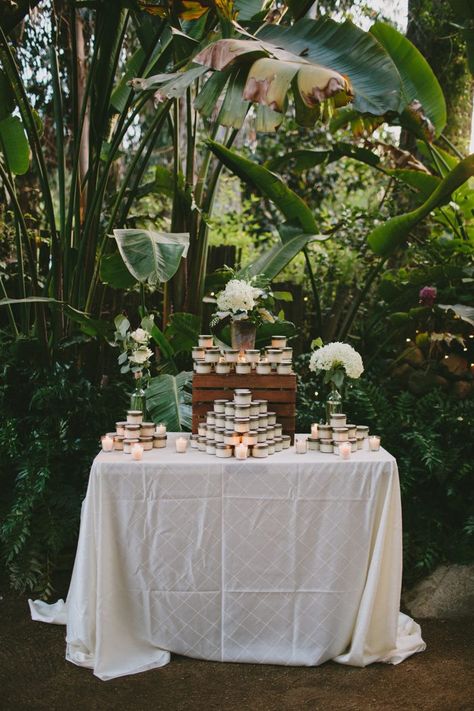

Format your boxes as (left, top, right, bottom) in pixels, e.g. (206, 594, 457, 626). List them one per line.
(0, 593, 474, 711)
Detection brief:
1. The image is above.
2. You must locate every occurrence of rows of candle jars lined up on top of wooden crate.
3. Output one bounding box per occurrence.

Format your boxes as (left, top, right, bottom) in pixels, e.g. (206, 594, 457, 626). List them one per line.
(192, 335, 293, 375)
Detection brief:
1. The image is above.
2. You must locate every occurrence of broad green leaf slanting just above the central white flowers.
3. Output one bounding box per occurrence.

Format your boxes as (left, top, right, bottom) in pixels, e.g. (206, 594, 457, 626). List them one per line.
(240, 225, 330, 279)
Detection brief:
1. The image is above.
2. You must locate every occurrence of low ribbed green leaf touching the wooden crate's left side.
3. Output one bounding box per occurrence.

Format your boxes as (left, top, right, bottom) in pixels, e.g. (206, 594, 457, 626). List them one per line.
(146, 372, 193, 432)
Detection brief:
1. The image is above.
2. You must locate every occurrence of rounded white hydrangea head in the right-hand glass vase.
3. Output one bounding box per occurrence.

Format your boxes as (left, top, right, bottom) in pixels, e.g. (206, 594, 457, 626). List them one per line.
(309, 341, 364, 389)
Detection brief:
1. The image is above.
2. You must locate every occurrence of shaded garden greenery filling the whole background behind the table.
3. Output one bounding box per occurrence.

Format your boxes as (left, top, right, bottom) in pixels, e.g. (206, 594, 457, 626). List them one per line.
(0, 0, 474, 596)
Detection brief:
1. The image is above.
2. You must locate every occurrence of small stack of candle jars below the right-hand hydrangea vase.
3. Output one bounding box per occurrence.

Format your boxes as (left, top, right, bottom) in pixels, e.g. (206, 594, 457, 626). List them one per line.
(307, 413, 369, 455)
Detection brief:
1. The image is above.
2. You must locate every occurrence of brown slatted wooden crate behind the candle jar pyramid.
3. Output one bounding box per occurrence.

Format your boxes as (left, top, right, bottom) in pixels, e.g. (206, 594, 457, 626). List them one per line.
(193, 373, 296, 441)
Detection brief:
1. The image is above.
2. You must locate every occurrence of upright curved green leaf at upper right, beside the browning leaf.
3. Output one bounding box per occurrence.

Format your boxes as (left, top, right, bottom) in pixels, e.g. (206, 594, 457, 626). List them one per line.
(370, 22, 446, 139)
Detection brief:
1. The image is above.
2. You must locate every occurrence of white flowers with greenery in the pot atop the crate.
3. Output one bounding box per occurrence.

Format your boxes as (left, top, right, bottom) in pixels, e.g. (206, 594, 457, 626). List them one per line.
(211, 277, 275, 326)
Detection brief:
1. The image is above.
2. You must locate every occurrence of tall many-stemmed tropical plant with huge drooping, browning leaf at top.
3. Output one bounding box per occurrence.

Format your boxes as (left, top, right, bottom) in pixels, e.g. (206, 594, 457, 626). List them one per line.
(0, 0, 418, 362)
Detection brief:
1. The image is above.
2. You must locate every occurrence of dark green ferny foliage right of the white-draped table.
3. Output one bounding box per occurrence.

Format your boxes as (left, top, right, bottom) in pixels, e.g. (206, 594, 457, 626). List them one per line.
(297, 356, 474, 584)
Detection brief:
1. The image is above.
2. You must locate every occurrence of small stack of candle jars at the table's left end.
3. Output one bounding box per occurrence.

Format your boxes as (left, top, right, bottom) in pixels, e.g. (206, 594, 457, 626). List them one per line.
(102, 410, 167, 454)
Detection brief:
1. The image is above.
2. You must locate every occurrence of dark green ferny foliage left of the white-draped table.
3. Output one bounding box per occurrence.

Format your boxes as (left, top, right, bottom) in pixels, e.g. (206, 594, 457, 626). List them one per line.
(0, 340, 127, 597)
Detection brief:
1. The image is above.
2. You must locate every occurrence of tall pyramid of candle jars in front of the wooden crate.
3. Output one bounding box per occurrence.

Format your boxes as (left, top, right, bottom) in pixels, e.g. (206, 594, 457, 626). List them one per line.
(191, 388, 290, 459)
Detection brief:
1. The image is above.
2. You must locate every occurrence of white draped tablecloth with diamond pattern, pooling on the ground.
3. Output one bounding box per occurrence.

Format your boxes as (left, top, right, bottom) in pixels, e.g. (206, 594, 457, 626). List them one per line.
(30, 435, 425, 680)
